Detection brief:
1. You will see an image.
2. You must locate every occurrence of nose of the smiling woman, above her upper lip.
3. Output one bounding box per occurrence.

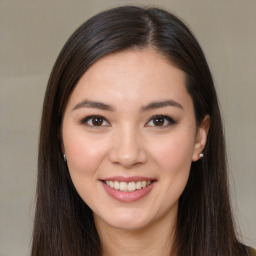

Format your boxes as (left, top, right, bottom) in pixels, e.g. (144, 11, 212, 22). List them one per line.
(109, 127, 148, 169)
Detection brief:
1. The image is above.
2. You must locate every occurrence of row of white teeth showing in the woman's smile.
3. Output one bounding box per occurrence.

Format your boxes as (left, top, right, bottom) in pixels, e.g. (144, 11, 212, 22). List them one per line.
(105, 180, 152, 192)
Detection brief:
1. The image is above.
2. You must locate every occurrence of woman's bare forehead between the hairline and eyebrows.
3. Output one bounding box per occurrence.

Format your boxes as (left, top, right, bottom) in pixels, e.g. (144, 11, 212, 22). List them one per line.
(66, 48, 191, 110)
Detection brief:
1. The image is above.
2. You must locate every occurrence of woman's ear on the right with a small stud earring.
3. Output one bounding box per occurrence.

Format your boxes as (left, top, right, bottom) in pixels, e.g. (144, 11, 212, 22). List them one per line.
(192, 115, 210, 162)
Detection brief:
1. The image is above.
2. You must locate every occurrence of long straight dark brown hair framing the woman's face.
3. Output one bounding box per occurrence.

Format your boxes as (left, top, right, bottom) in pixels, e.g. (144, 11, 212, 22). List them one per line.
(32, 6, 244, 256)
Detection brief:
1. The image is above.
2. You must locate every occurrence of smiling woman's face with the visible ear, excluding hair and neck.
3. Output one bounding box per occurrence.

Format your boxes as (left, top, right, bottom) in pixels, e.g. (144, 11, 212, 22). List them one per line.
(62, 49, 207, 230)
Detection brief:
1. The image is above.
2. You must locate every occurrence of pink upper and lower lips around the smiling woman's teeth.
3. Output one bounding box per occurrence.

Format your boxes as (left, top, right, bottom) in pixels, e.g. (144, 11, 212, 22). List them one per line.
(100, 176, 156, 203)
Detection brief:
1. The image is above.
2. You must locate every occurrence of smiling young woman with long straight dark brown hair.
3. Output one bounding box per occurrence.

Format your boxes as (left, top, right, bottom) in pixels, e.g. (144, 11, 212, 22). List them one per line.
(32, 7, 253, 256)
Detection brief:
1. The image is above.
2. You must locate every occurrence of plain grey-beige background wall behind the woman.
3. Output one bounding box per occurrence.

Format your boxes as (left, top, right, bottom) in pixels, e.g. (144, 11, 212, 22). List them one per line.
(0, 0, 256, 256)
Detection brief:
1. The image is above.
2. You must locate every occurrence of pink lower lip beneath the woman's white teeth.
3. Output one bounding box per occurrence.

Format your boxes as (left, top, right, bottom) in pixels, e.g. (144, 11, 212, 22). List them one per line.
(102, 182, 155, 202)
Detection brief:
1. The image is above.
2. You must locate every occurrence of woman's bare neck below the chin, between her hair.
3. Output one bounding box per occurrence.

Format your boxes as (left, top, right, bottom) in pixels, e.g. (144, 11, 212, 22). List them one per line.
(95, 213, 176, 256)
